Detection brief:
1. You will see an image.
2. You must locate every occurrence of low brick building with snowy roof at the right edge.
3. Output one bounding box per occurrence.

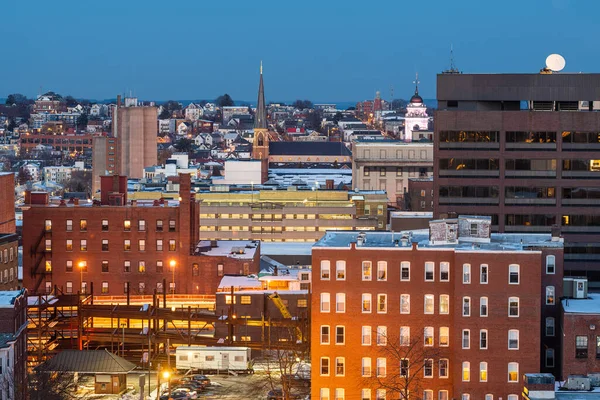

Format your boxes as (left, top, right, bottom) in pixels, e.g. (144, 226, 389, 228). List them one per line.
(560, 278, 600, 380)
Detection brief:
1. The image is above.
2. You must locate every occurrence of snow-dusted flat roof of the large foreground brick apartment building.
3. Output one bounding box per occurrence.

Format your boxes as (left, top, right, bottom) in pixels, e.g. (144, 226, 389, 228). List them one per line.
(314, 229, 563, 252)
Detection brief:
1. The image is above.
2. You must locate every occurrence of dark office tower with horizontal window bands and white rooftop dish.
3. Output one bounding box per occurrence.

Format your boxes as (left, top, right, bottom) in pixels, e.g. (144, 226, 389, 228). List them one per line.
(434, 70, 600, 281)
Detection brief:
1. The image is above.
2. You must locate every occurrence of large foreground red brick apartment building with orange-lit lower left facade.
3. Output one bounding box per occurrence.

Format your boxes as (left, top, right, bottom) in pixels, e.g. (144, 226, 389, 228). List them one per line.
(311, 217, 563, 400)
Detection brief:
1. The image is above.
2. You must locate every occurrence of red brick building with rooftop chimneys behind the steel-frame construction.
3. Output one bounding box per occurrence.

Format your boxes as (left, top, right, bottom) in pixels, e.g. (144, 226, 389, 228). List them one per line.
(23, 174, 260, 296)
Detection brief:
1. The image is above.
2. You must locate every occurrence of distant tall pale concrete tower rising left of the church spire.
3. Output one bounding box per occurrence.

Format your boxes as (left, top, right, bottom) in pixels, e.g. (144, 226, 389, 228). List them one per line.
(113, 96, 158, 179)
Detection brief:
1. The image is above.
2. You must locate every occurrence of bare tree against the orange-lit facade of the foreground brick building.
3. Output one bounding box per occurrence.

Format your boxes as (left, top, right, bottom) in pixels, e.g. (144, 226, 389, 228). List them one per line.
(361, 328, 448, 400)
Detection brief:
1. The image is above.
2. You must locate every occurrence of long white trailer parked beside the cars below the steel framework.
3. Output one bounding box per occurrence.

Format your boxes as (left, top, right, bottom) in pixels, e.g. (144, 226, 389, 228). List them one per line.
(175, 346, 252, 373)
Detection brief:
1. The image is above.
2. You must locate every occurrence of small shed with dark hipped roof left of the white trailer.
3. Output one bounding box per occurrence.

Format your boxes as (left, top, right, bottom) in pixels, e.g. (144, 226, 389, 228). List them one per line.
(41, 349, 136, 394)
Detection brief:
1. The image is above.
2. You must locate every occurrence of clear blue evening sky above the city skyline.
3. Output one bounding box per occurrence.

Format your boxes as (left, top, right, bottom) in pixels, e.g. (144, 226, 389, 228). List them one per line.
(0, 0, 600, 101)
